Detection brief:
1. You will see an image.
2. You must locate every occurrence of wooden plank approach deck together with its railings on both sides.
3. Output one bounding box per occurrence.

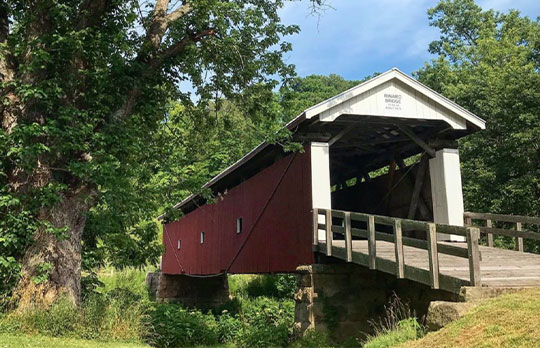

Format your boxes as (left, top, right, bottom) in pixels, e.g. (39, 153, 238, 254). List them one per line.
(313, 209, 540, 293)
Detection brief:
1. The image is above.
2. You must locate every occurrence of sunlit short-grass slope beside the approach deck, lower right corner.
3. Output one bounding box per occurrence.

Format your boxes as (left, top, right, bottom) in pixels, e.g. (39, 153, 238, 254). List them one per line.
(399, 289, 540, 348)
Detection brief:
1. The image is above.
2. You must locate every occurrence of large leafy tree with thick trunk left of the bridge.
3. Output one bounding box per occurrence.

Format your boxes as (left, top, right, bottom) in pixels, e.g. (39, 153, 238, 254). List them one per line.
(0, 0, 321, 307)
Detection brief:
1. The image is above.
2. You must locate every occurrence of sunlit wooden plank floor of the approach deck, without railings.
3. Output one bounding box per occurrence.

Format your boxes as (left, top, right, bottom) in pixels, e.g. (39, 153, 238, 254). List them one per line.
(317, 240, 540, 292)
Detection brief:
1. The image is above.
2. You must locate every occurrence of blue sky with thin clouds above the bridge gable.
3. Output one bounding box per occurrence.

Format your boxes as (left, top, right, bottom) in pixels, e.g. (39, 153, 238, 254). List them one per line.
(281, 0, 540, 80)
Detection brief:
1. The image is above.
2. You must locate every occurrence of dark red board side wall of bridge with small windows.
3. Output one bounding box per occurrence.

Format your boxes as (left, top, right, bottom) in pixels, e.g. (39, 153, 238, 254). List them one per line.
(162, 147, 313, 275)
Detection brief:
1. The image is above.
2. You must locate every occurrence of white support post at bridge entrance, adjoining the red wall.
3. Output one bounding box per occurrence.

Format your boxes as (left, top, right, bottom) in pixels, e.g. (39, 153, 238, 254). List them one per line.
(311, 142, 332, 240)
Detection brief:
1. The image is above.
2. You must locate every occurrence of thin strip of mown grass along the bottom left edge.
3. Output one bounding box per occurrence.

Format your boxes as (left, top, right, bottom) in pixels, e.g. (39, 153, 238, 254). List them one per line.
(0, 334, 150, 348)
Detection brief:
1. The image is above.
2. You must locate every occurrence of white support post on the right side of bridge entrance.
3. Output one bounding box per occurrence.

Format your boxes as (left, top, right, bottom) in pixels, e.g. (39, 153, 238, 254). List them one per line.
(429, 149, 465, 242)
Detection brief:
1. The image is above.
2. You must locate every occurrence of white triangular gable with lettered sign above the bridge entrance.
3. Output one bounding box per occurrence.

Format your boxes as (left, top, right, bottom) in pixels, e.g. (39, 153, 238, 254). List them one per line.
(306, 69, 485, 129)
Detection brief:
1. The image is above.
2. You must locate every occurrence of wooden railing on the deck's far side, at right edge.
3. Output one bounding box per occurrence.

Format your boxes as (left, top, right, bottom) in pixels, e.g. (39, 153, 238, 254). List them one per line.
(463, 212, 540, 251)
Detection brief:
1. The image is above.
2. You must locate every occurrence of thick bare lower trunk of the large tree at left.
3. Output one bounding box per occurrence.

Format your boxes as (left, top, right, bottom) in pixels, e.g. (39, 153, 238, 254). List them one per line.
(14, 189, 94, 310)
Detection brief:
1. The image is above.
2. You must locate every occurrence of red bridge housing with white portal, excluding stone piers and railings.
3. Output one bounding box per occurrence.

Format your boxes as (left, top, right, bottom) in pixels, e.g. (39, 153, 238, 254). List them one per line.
(162, 69, 485, 275)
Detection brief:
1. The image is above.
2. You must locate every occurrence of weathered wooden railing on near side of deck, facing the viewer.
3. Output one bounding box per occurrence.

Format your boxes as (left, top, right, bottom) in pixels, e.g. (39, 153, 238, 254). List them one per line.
(313, 209, 482, 292)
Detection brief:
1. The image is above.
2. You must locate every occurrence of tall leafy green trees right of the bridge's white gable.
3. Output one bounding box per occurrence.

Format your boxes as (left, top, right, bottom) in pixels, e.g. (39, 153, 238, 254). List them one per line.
(417, 0, 540, 220)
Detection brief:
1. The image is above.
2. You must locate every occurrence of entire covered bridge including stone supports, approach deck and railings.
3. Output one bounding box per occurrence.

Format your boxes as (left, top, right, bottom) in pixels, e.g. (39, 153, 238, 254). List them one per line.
(153, 69, 540, 337)
